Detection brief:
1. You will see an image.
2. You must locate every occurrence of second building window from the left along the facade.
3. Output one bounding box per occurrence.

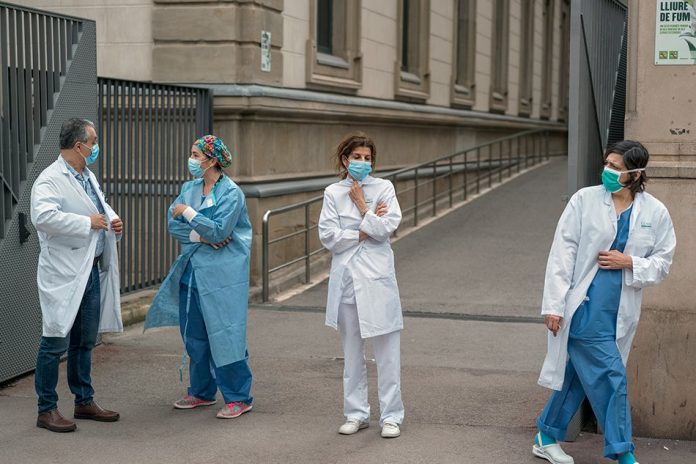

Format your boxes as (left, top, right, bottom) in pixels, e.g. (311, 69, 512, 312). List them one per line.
(395, 0, 430, 101)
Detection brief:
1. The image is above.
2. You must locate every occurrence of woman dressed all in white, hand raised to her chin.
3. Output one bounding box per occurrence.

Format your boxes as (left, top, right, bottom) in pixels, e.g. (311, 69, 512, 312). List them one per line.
(319, 133, 404, 438)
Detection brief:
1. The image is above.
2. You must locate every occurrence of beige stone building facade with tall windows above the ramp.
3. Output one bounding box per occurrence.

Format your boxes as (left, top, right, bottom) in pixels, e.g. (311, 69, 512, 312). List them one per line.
(10, 0, 569, 284)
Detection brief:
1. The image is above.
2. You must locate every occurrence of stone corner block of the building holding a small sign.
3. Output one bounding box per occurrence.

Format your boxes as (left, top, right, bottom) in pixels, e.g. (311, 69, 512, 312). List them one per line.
(152, 0, 283, 86)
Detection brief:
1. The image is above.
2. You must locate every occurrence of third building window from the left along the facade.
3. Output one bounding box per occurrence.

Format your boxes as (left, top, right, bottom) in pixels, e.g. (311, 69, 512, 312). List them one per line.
(452, 0, 476, 108)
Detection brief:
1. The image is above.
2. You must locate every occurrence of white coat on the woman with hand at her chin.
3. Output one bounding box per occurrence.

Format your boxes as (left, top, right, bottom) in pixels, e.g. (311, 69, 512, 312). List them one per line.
(319, 176, 403, 338)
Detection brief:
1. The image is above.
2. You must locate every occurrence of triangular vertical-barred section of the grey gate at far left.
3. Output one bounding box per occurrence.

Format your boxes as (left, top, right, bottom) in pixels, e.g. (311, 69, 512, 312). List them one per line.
(0, 3, 82, 239)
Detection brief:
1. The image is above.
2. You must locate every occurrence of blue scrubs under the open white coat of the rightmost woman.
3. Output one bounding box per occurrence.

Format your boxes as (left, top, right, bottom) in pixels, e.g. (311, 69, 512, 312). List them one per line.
(537, 208, 635, 459)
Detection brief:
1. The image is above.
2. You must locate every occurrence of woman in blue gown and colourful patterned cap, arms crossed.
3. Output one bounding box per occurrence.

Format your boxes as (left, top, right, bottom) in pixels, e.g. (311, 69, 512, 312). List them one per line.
(145, 135, 252, 419)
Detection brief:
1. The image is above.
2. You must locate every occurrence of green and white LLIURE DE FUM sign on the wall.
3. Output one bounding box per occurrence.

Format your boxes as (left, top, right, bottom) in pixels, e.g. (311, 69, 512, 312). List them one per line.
(655, 0, 696, 64)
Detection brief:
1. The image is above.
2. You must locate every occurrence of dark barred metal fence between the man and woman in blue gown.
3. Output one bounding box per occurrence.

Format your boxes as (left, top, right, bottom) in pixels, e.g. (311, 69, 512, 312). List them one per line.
(98, 78, 212, 293)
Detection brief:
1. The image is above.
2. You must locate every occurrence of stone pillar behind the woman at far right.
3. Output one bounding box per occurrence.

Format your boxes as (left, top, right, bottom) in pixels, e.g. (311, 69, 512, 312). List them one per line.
(625, 0, 696, 440)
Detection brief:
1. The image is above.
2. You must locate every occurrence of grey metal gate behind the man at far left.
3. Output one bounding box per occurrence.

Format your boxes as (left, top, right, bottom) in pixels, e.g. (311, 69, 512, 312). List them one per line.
(0, 3, 97, 382)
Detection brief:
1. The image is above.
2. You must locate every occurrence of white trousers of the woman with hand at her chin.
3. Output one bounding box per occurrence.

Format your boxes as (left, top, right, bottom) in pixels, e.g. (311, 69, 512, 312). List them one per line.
(338, 303, 404, 426)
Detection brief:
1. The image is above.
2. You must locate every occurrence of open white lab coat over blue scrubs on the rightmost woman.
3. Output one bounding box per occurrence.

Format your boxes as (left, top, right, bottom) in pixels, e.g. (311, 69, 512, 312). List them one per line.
(539, 185, 676, 390)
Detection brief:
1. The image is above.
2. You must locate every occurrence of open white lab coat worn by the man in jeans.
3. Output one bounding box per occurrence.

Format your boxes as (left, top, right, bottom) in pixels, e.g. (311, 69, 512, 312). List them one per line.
(31, 157, 123, 337)
